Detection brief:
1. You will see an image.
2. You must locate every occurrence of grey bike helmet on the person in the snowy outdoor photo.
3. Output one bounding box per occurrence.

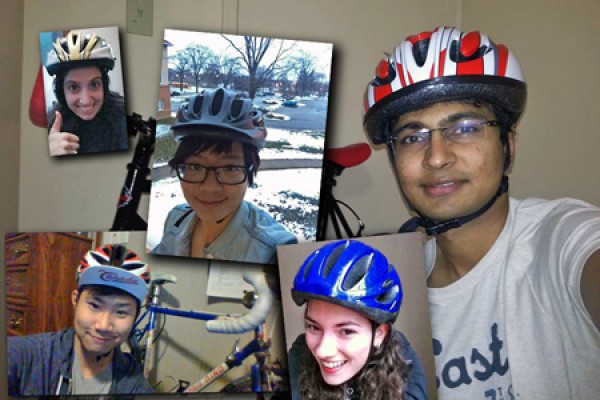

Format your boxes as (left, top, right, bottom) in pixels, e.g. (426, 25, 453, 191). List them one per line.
(171, 88, 267, 150)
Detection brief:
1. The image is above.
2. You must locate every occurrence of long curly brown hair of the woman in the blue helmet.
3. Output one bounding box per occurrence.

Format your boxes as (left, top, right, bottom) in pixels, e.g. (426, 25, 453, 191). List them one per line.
(298, 323, 410, 400)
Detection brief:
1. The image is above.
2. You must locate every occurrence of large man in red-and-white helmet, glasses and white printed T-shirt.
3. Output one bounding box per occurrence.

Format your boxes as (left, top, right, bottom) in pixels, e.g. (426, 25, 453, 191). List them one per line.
(363, 28, 600, 400)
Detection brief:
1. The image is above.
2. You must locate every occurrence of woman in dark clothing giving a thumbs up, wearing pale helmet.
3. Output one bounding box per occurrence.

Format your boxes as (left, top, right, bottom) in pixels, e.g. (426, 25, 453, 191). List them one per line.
(46, 31, 128, 156)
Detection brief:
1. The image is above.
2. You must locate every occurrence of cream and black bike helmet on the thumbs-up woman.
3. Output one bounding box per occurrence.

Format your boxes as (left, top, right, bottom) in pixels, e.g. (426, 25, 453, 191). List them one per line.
(46, 31, 115, 75)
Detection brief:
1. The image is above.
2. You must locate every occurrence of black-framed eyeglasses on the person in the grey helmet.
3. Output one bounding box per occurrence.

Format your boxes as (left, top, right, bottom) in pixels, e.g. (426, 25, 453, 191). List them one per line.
(176, 163, 254, 185)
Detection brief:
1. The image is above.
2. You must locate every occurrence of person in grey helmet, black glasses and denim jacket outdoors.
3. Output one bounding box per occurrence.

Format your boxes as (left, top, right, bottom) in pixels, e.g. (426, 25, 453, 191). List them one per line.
(153, 89, 297, 264)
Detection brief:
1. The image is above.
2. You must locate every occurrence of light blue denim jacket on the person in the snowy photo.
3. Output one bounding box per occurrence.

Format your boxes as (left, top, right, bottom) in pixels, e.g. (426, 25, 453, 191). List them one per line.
(152, 201, 298, 264)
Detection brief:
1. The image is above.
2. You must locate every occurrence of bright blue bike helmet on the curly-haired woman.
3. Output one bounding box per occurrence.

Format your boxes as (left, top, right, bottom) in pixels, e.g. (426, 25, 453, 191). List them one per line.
(292, 240, 402, 324)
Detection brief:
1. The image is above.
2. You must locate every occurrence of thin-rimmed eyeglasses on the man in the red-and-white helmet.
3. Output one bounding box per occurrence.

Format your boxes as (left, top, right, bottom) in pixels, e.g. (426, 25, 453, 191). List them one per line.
(392, 118, 500, 153)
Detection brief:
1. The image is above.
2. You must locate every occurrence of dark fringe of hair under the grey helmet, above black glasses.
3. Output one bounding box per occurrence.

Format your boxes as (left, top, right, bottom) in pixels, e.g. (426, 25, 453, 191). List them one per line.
(169, 136, 260, 185)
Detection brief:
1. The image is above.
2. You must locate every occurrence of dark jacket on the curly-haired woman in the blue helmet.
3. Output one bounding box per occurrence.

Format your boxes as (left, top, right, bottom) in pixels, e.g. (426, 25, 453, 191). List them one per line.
(288, 329, 427, 400)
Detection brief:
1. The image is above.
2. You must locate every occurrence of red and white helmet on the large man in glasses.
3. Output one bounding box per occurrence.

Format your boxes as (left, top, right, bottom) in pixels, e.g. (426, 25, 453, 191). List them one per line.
(363, 27, 527, 144)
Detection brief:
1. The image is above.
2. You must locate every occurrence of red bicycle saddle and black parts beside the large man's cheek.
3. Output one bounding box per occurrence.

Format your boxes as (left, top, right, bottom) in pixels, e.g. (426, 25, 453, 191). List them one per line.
(317, 143, 371, 241)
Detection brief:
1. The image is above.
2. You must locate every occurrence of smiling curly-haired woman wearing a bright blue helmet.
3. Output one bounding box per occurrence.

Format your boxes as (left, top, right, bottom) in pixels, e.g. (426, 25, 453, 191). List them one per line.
(288, 241, 426, 400)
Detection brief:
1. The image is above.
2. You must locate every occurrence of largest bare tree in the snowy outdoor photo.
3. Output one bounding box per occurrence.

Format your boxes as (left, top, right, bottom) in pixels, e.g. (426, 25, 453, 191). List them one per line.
(221, 35, 293, 98)
